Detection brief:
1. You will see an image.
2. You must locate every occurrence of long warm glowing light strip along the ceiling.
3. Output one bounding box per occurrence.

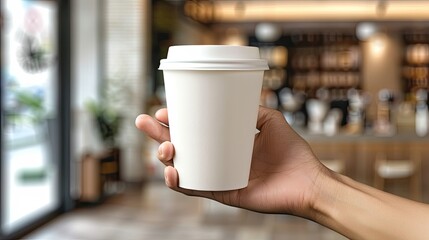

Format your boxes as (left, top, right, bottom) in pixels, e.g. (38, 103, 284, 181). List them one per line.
(185, 0, 429, 22)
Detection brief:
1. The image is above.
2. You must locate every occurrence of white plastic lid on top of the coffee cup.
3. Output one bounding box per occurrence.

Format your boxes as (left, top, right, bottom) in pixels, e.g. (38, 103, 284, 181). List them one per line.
(159, 45, 269, 70)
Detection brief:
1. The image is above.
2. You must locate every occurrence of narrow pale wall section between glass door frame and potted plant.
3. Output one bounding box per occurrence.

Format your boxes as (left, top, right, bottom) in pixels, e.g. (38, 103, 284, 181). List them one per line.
(71, 0, 102, 197)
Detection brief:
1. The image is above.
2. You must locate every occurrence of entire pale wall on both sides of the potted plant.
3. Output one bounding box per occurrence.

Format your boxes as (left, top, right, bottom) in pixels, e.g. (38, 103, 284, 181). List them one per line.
(71, 0, 150, 193)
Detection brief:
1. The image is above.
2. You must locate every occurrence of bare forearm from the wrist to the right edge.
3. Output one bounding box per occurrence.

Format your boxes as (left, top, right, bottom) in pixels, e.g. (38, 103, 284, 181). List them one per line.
(311, 174, 429, 239)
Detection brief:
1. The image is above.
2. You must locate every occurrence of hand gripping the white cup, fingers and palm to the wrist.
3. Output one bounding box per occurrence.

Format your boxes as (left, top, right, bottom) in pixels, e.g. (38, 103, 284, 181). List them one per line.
(136, 107, 329, 217)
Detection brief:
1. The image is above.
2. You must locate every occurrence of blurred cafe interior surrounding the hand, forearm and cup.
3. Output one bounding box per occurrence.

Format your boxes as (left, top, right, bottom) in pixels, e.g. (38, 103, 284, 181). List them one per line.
(0, 0, 429, 239)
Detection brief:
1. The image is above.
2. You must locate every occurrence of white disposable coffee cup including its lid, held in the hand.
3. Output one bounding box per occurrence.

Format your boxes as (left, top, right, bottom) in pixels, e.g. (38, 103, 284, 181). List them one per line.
(159, 45, 268, 191)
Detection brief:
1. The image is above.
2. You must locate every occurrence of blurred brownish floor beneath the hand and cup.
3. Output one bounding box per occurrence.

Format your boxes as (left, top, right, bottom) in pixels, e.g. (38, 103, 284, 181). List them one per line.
(24, 182, 345, 240)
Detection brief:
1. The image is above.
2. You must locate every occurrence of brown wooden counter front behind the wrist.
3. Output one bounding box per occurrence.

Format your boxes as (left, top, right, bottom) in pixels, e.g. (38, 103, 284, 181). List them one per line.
(295, 129, 429, 202)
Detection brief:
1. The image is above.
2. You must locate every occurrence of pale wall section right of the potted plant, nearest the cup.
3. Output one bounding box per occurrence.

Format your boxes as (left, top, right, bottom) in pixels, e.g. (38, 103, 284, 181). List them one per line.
(103, 0, 150, 182)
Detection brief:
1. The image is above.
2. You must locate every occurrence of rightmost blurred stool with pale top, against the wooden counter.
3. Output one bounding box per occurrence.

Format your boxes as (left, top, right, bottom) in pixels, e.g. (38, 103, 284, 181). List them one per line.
(374, 152, 422, 201)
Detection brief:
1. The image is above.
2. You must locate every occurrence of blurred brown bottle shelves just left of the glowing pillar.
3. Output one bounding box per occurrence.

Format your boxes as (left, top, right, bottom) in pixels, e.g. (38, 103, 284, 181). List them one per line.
(289, 34, 360, 99)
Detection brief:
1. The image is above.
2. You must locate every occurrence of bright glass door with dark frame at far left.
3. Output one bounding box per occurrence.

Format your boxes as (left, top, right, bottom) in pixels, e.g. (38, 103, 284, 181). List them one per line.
(0, 0, 60, 236)
